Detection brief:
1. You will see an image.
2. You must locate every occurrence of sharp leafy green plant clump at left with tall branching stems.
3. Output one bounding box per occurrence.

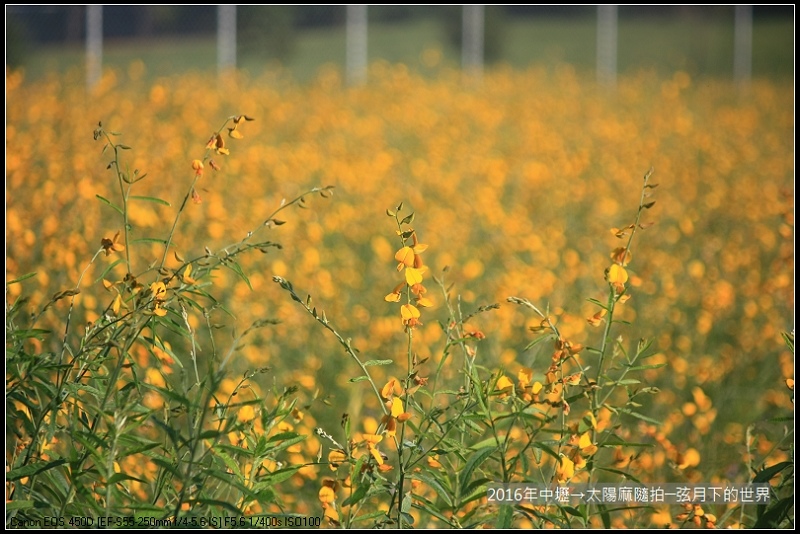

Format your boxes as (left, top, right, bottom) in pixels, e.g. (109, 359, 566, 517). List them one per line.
(6, 115, 330, 527)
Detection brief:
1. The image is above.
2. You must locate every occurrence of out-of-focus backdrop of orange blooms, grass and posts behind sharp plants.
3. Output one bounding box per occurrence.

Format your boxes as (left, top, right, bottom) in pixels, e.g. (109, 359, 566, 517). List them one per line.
(6, 5, 795, 524)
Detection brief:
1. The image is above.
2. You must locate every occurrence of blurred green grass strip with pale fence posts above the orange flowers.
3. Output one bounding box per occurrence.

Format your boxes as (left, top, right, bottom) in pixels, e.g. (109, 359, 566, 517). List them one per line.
(6, 5, 794, 86)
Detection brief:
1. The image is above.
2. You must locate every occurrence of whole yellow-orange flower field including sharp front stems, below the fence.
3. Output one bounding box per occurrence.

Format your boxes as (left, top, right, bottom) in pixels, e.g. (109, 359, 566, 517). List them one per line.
(6, 63, 795, 527)
